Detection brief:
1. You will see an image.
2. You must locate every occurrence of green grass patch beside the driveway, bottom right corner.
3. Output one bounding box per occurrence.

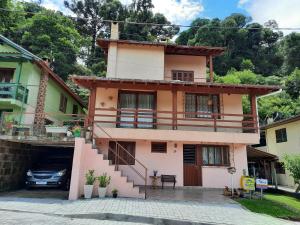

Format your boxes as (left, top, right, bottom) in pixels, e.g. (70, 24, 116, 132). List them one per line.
(237, 194, 300, 221)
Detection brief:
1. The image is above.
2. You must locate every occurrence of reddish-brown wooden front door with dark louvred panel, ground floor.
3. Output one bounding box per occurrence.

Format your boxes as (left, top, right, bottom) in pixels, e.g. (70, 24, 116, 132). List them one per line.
(183, 145, 202, 186)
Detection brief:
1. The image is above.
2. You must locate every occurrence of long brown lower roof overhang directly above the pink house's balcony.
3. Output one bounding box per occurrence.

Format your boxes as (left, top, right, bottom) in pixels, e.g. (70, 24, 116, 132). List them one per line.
(71, 75, 280, 96)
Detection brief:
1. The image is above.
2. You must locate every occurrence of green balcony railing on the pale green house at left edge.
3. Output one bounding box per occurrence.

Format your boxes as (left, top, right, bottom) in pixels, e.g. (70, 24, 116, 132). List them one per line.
(0, 83, 29, 103)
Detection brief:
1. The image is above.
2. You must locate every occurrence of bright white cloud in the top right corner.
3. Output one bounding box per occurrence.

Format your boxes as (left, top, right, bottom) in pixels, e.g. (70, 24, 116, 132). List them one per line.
(238, 0, 300, 33)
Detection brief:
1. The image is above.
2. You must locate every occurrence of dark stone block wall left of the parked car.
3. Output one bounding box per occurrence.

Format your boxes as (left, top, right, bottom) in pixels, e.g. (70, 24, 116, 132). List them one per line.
(0, 140, 33, 191)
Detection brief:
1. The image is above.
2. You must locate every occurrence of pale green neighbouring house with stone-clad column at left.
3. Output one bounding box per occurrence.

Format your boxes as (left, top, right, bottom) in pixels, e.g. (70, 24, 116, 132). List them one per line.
(0, 35, 84, 130)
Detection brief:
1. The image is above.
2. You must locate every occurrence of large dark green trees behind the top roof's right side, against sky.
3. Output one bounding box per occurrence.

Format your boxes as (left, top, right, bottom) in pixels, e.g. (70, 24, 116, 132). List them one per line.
(176, 14, 283, 76)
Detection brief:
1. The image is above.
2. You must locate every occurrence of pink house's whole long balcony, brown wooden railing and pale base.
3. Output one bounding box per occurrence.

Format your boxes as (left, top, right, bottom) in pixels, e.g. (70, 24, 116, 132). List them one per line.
(93, 108, 259, 144)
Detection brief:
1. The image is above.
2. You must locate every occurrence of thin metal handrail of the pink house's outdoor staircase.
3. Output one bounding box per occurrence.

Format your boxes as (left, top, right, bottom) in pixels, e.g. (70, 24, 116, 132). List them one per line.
(93, 123, 148, 199)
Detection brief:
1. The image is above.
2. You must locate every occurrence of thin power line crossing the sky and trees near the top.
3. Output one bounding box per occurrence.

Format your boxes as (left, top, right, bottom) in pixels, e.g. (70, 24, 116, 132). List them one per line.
(0, 8, 300, 31)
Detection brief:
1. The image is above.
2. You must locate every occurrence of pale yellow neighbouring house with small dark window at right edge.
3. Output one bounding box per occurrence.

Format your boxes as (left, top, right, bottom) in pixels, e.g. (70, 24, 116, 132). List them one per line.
(261, 115, 300, 187)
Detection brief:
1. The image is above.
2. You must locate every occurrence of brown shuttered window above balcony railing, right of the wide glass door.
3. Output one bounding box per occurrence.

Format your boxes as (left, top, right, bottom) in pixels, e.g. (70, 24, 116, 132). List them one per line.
(185, 94, 220, 118)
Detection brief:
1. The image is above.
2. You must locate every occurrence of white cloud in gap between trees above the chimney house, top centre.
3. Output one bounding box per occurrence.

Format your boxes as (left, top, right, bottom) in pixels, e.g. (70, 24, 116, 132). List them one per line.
(121, 0, 204, 23)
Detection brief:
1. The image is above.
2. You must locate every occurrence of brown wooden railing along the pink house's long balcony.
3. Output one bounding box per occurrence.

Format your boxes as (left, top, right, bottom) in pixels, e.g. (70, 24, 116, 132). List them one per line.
(94, 108, 258, 133)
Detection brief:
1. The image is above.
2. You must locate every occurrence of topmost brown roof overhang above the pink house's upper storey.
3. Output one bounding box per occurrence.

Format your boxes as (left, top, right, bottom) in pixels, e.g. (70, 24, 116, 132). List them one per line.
(97, 39, 225, 56)
